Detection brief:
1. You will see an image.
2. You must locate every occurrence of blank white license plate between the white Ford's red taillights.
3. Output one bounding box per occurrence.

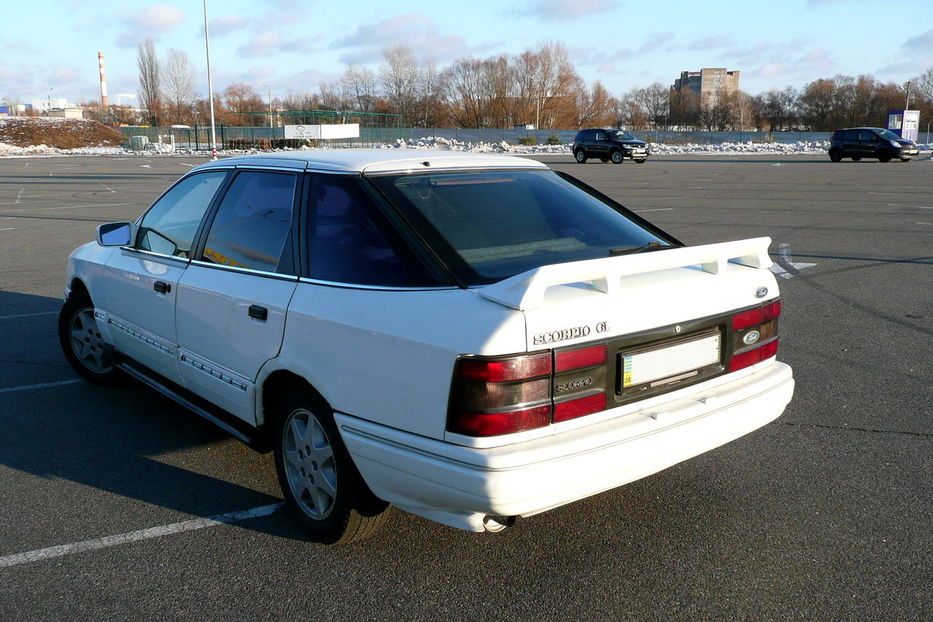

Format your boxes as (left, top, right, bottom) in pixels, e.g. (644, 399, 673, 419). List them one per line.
(621, 331, 721, 389)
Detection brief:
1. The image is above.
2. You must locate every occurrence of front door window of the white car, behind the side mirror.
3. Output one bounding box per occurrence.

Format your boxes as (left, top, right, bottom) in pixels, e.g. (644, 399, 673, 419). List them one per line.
(136, 171, 227, 258)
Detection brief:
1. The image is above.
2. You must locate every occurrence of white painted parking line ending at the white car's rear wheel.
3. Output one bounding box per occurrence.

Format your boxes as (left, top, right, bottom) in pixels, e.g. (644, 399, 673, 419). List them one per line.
(0, 503, 284, 568)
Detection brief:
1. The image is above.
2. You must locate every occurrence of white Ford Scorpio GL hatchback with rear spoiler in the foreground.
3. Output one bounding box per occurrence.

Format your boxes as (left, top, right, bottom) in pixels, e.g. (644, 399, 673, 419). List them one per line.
(59, 150, 794, 542)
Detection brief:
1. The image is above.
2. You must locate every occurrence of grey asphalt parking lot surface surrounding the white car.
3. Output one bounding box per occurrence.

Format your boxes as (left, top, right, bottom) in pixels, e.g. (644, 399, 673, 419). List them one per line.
(0, 155, 933, 620)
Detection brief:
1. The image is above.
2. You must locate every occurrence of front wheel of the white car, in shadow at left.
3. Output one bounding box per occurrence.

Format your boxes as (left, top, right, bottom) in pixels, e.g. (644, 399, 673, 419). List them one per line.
(58, 293, 119, 384)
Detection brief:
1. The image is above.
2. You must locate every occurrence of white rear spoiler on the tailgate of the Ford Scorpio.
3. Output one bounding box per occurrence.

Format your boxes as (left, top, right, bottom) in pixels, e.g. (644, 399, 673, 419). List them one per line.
(477, 238, 772, 311)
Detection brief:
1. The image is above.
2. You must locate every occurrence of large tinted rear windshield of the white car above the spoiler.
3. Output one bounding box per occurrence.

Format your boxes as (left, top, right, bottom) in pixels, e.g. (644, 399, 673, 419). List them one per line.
(371, 171, 670, 285)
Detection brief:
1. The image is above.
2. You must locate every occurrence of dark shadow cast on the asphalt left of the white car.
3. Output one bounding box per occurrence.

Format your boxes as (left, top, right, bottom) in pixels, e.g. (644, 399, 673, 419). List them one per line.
(0, 291, 306, 540)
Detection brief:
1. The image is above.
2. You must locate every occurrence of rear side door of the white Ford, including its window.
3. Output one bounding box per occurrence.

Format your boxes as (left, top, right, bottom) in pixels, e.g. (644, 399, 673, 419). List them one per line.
(176, 169, 301, 423)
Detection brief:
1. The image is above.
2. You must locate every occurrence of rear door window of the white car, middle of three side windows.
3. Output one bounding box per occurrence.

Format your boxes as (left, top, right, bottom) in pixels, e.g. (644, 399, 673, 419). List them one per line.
(201, 171, 298, 274)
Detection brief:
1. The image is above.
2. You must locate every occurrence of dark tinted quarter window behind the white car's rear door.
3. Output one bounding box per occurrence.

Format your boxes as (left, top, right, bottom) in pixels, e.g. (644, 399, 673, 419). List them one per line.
(306, 175, 438, 287)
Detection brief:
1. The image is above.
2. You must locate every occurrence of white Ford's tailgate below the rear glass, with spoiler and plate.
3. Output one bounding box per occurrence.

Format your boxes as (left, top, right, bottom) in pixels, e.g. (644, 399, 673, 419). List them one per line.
(479, 238, 779, 410)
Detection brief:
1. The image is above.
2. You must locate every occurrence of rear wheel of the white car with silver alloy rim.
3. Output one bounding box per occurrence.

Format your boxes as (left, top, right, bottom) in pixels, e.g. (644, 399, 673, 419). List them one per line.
(275, 389, 388, 544)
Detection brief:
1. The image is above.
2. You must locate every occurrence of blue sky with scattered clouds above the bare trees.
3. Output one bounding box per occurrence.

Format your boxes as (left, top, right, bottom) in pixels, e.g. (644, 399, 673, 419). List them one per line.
(0, 0, 933, 105)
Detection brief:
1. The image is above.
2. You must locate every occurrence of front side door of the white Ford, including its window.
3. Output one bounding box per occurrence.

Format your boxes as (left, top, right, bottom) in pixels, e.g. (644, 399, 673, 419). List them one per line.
(95, 170, 227, 382)
